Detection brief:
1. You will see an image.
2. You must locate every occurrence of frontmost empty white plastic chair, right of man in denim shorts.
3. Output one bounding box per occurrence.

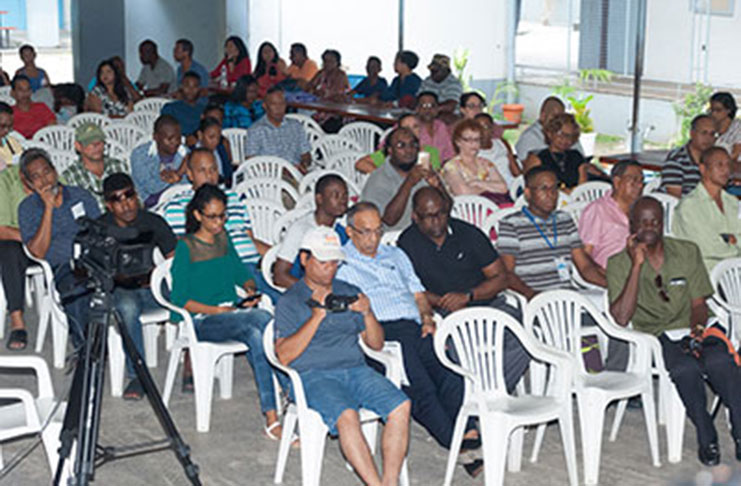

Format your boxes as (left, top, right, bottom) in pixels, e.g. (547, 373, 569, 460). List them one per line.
(435, 307, 578, 486)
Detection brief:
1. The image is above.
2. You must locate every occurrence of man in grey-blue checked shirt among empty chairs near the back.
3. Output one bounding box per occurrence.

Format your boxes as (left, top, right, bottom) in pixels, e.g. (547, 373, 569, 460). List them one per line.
(245, 87, 311, 172)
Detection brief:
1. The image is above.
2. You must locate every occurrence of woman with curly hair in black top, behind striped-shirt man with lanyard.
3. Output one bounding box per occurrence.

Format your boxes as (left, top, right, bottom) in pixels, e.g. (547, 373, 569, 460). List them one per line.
(523, 113, 610, 193)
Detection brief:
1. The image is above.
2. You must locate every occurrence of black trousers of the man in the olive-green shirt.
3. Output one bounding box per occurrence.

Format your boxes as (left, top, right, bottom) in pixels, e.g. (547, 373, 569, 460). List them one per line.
(659, 334, 741, 447)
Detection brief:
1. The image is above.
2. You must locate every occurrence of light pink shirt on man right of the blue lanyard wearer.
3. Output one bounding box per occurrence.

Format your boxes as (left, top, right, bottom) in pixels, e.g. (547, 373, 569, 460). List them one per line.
(579, 191, 630, 268)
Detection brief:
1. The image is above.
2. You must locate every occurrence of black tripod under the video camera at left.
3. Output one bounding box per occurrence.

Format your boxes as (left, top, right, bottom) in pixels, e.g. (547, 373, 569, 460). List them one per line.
(53, 278, 201, 486)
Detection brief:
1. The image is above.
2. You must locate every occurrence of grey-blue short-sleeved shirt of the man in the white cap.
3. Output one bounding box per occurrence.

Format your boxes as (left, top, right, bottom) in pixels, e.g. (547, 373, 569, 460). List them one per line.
(275, 278, 365, 373)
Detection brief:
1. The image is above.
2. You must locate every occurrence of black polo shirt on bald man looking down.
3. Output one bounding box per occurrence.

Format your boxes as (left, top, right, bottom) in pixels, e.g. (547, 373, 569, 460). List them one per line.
(398, 218, 499, 302)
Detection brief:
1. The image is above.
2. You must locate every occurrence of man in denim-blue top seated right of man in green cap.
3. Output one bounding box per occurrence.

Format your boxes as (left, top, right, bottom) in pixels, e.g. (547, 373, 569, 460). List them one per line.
(130, 115, 188, 208)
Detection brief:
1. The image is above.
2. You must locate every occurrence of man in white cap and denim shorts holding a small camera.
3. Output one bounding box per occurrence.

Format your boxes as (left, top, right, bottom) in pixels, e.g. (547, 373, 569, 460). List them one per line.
(275, 226, 410, 486)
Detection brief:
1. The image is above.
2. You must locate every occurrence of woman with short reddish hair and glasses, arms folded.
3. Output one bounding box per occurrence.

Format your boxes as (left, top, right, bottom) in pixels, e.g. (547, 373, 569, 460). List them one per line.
(441, 120, 512, 207)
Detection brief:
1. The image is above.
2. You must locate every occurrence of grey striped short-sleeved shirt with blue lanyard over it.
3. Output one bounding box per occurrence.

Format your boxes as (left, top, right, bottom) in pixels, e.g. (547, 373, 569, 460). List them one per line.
(497, 208, 583, 291)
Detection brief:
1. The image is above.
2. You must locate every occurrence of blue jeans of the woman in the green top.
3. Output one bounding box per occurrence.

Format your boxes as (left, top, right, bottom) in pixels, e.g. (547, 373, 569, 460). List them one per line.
(193, 309, 276, 413)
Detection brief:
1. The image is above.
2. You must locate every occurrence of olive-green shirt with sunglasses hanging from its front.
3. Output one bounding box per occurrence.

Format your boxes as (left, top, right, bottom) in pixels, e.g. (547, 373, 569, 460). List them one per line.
(607, 237, 713, 335)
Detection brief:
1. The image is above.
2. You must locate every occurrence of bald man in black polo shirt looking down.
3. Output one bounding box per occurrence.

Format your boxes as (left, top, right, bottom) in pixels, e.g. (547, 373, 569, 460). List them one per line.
(398, 187, 529, 390)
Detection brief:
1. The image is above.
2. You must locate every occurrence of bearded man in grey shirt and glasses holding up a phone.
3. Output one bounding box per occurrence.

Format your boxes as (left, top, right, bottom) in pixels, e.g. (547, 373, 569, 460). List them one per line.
(360, 128, 452, 230)
